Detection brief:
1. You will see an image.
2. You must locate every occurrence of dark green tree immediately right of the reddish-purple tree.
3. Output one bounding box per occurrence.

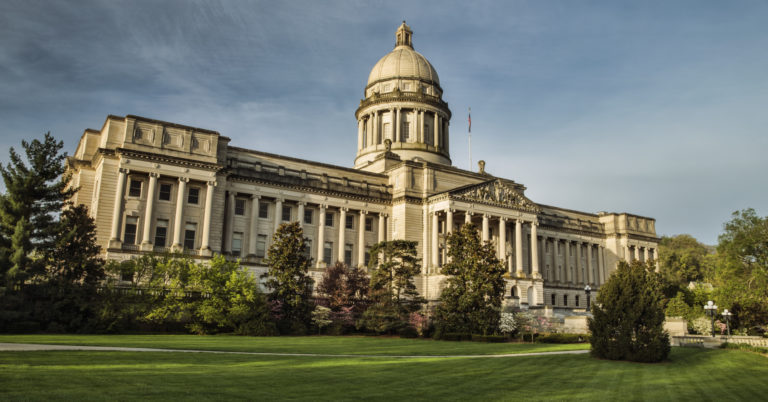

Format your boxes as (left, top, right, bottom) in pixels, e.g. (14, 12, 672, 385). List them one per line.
(361, 240, 424, 333)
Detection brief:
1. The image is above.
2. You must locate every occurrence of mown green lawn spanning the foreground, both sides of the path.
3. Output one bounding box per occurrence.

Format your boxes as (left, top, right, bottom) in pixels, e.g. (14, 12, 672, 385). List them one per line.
(0, 337, 768, 401)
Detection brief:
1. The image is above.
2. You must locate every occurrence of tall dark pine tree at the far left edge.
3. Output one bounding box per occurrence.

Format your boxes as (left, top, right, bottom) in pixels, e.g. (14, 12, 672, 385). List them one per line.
(0, 133, 77, 285)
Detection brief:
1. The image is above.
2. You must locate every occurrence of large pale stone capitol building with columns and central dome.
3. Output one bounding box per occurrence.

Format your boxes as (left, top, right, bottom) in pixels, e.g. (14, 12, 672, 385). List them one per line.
(69, 23, 659, 309)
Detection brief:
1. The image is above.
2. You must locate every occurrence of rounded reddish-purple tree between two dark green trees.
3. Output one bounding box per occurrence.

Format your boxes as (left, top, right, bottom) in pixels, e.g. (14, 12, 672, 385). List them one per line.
(317, 261, 370, 329)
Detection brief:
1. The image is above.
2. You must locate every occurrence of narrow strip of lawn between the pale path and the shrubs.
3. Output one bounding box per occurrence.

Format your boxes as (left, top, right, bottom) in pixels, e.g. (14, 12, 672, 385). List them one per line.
(0, 335, 589, 356)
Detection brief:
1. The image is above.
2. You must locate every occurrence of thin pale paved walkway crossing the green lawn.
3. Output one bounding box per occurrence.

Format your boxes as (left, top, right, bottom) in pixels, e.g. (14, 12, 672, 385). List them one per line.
(0, 343, 589, 359)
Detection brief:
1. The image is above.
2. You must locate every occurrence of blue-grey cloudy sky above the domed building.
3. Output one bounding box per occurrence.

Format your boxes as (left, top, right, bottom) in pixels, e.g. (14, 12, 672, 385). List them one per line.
(0, 0, 768, 244)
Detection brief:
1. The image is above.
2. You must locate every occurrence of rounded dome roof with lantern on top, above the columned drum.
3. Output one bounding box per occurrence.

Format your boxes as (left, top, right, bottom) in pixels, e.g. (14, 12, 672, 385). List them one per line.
(366, 23, 440, 87)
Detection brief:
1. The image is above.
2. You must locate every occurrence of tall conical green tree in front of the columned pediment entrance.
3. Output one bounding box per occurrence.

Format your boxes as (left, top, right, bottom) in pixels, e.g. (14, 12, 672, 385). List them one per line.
(435, 224, 505, 335)
